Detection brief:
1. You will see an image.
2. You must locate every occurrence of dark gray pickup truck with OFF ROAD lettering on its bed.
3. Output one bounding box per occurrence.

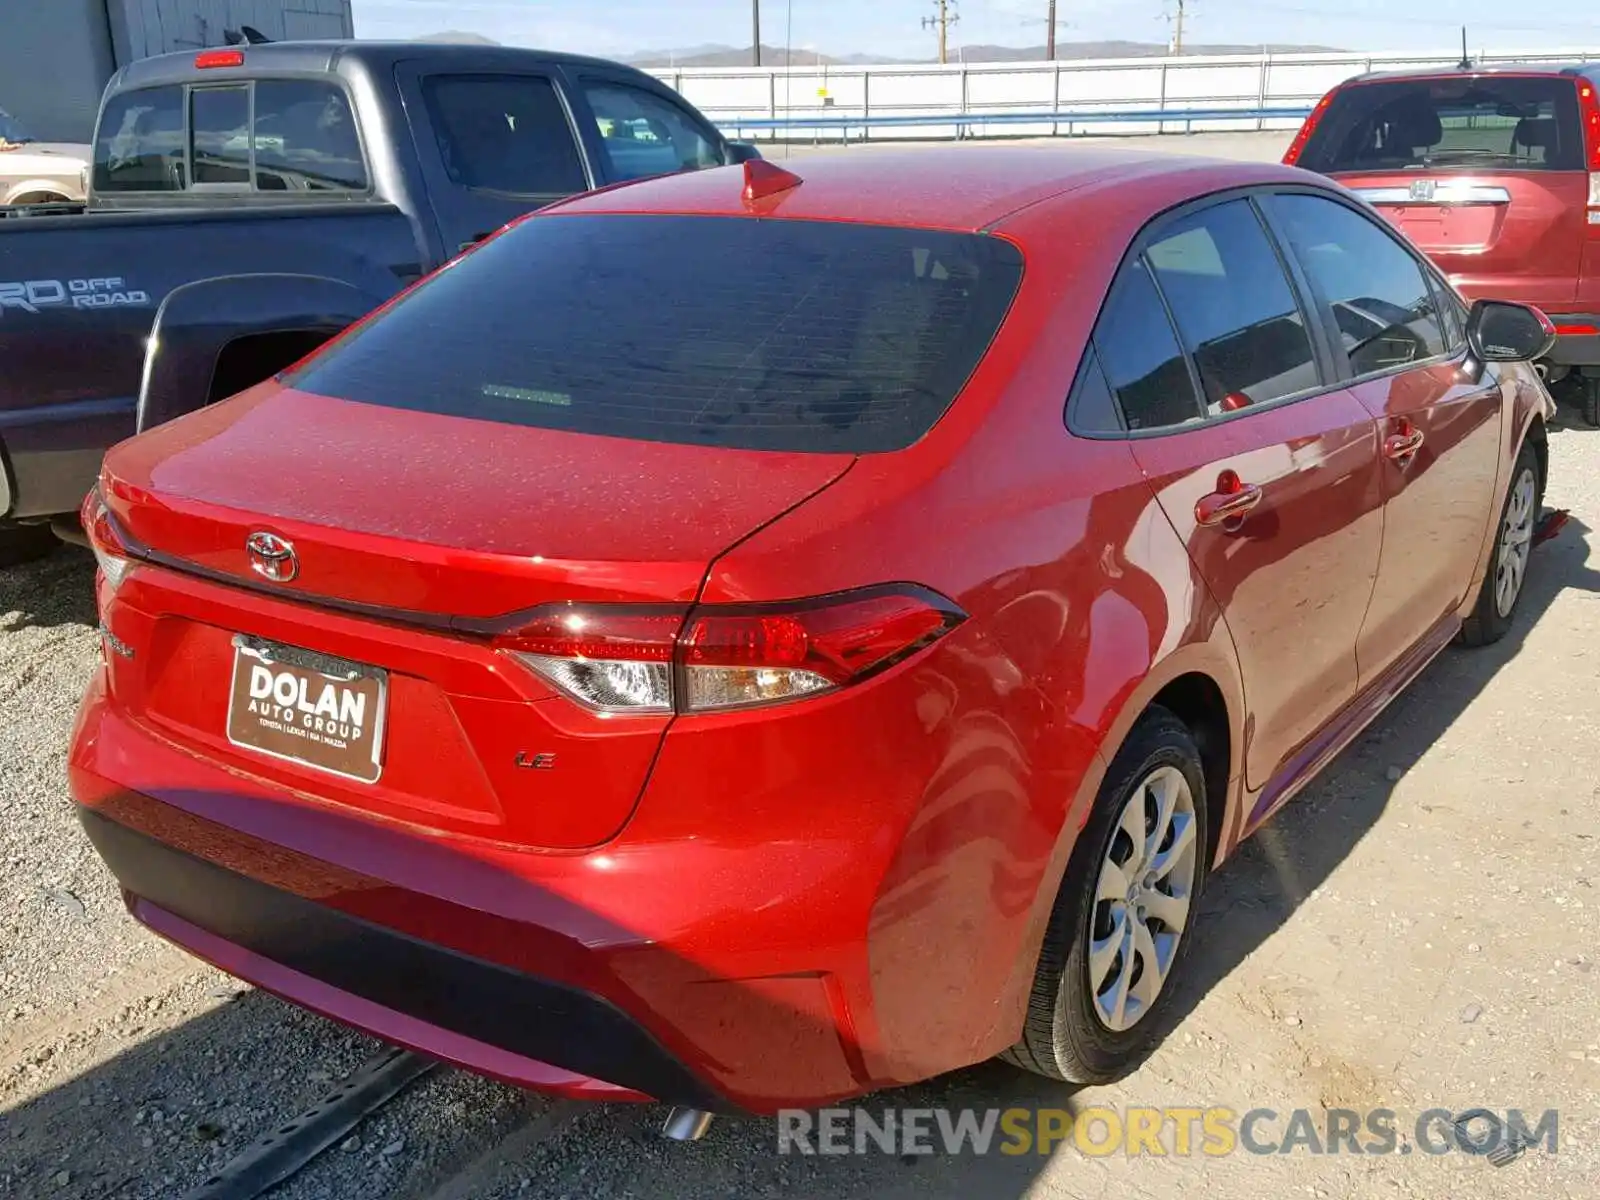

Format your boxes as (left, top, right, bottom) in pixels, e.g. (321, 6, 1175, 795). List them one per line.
(0, 42, 757, 565)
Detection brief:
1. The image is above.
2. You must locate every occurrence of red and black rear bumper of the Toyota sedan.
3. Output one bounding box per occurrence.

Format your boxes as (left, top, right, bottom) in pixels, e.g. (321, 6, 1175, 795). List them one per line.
(69, 667, 1043, 1112)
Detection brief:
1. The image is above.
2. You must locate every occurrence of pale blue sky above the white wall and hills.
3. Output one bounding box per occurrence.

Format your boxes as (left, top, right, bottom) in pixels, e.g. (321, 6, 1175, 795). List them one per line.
(354, 0, 1600, 58)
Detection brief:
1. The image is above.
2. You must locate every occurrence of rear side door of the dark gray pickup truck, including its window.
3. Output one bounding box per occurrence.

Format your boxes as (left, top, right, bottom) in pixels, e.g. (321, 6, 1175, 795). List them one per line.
(398, 62, 595, 253)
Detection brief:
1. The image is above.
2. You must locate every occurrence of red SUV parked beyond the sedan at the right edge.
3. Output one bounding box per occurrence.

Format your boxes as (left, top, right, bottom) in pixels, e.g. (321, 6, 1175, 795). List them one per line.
(1283, 66, 1600, 426)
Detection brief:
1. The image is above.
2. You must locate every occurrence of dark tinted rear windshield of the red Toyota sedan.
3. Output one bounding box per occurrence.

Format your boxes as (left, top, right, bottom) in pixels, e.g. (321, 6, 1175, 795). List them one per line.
(288, 214, 1022, 453)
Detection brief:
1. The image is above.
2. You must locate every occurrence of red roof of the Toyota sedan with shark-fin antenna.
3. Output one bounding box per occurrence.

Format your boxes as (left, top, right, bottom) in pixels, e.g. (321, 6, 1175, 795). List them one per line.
(544, 144, 1326, 232)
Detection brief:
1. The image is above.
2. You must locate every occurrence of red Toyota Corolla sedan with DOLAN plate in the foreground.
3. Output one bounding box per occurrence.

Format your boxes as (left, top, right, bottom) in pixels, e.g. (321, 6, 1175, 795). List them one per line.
(70, 147, 1550, 1112)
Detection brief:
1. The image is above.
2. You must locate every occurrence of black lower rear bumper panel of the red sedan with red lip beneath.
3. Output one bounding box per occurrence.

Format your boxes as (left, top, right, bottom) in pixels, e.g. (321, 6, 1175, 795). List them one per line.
(78, 794, 738, 1110)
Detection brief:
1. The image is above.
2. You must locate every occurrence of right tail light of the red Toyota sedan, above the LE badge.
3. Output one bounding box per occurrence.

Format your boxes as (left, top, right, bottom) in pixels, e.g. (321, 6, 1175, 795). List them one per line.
(496, 586, 965, 714)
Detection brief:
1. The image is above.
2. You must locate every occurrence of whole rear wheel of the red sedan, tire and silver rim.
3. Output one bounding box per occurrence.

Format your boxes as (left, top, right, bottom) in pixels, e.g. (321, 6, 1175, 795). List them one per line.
(1005, 707, 1208, 1083)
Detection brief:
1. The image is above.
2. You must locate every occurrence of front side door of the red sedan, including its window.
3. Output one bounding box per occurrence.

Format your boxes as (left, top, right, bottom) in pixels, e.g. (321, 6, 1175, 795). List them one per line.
(1266, 195, 1504, 685)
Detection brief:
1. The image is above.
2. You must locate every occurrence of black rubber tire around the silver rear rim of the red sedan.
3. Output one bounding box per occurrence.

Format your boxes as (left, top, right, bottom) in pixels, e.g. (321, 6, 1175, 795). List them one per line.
(1002, 707, 1210, 1083)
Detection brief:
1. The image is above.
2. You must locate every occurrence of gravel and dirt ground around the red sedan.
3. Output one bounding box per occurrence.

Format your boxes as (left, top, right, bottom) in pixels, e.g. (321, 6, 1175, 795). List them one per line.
(0, 131, 1600, 1200)
